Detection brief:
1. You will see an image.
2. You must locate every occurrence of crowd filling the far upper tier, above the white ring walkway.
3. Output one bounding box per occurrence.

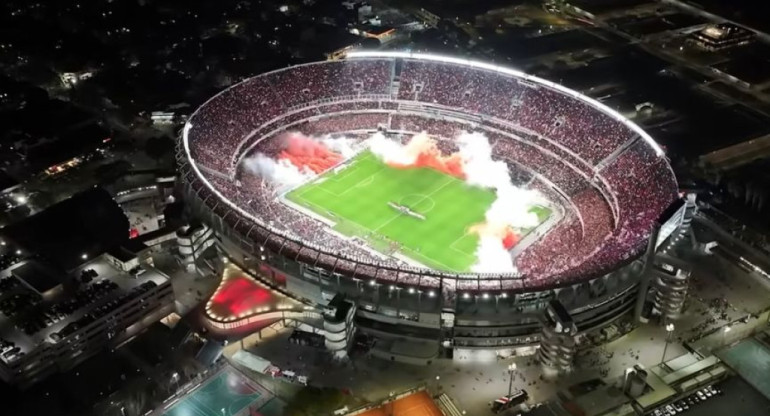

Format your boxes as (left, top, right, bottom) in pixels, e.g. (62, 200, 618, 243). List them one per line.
(190, 59, 634, 173)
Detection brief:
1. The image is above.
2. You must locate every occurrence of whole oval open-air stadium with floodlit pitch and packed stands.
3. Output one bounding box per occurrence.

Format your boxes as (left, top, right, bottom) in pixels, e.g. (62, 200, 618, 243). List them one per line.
(177, 51, 678, 350)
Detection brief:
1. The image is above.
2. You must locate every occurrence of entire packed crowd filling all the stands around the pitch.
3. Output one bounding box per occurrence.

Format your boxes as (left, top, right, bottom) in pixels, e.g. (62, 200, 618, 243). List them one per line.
(183, 56, 676, 290)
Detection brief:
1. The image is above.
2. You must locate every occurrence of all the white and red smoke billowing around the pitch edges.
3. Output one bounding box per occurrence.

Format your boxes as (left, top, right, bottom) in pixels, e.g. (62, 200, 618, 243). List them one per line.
(244, 128, 545, 273)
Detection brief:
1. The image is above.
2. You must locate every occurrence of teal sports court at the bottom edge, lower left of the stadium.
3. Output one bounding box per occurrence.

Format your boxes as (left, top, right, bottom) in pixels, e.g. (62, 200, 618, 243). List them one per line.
(163, 367, 278, 416)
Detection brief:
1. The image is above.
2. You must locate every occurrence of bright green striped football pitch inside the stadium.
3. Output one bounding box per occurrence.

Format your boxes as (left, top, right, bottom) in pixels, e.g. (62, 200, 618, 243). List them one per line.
(286, 151, 550, 272)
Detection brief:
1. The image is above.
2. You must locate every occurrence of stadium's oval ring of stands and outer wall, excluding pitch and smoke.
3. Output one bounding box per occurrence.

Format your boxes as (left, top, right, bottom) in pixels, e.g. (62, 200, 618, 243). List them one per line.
(177, 52, 677, 351)
